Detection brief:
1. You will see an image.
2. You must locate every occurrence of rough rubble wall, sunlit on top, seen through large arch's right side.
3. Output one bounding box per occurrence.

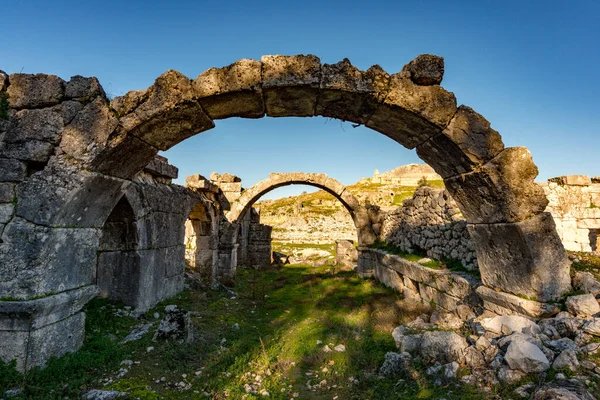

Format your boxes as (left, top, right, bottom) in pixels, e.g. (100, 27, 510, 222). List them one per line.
(379, 187, 477, 270)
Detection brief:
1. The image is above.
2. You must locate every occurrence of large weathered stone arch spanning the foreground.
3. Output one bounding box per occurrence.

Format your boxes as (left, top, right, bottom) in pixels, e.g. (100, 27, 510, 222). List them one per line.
(0, 55, 570, 301)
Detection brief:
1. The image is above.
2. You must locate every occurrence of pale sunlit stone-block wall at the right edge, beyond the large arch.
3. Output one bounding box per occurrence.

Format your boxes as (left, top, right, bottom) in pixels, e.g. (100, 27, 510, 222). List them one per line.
(541, 175, 600, 252)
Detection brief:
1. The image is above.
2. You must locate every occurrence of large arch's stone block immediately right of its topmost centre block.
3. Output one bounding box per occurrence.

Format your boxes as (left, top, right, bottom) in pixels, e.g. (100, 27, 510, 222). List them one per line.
(316, 59, 390, 124)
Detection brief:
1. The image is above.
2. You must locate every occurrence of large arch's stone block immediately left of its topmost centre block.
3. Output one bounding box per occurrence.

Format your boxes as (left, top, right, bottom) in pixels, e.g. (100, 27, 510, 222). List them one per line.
(194, 60, 265, 119)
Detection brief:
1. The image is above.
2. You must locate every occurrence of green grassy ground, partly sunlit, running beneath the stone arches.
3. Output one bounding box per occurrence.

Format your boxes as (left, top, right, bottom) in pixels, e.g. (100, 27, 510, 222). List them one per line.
(0, 266, 494, 400)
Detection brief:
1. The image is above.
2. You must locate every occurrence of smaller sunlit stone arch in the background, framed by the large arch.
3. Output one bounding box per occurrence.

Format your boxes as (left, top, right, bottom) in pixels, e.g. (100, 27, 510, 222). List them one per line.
(226, 172, 376, 245)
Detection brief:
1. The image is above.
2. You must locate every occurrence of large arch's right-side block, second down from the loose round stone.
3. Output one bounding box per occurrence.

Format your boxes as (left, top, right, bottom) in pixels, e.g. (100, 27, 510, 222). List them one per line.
(417, 106, 504, 178)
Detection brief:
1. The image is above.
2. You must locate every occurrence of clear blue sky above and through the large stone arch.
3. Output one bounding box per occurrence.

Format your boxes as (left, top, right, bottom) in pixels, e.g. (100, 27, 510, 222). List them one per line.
(0, 0, 600, 200)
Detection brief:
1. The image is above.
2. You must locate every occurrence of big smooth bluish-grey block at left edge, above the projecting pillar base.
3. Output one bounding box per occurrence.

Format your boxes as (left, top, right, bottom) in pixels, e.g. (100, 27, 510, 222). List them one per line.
(0, 217, 100, 298)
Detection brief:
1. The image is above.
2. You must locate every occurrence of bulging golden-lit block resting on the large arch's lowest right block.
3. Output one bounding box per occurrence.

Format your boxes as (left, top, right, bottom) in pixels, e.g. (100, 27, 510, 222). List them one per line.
(444, 147, 548, 224)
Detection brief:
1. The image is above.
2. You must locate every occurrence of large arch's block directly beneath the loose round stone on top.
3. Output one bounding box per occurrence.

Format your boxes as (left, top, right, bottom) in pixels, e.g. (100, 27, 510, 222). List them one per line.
(366, 72, 456, 149)
